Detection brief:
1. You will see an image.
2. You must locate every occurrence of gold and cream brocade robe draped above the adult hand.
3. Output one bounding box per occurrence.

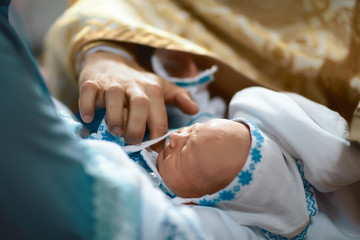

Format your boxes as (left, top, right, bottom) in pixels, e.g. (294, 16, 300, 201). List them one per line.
(45, 0, 360, 120)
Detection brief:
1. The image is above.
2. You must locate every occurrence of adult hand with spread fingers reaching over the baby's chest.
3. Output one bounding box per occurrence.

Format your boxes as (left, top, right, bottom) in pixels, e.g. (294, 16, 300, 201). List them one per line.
(79, 52, 198, 150)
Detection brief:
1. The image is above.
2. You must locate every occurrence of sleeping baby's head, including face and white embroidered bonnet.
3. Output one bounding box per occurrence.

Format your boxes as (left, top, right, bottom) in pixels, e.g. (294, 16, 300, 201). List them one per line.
(157, 118, 317, 238)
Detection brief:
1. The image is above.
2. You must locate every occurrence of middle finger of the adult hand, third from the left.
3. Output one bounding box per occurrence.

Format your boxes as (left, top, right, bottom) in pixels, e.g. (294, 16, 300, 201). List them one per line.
(124, 87, 150, 144)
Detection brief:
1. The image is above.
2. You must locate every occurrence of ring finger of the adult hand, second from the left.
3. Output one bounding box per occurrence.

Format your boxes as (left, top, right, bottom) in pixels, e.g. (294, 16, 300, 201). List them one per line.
(105, 84, 125, 135)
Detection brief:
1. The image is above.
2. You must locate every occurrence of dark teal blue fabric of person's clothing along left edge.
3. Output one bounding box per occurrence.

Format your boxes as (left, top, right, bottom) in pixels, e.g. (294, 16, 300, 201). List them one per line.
(0, 4, 93, 239)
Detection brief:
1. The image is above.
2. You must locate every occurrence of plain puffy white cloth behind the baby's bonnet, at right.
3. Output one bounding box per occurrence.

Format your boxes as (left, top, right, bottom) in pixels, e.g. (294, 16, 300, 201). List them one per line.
(229, 87, 360, 192)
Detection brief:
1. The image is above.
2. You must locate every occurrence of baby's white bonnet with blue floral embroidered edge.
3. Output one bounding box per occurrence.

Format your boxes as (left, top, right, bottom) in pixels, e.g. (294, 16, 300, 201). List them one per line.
(180, 119, 316, 239)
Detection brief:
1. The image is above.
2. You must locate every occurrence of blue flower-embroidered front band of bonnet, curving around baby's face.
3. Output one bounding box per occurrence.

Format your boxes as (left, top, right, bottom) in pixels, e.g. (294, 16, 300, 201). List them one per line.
(197, 119, 264, 206)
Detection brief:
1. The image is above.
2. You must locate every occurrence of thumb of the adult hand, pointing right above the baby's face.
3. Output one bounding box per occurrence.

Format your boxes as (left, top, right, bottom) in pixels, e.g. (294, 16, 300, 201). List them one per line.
(164, 81, 199, 114)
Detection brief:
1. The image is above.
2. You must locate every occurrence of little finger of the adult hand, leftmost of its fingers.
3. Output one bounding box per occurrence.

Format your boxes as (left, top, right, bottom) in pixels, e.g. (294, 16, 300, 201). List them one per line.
(79, 80, 100, 123)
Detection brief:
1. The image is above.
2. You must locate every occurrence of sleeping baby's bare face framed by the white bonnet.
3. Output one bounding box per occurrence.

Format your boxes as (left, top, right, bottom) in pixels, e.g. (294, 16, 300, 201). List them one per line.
(157, 119, 251, 198)
